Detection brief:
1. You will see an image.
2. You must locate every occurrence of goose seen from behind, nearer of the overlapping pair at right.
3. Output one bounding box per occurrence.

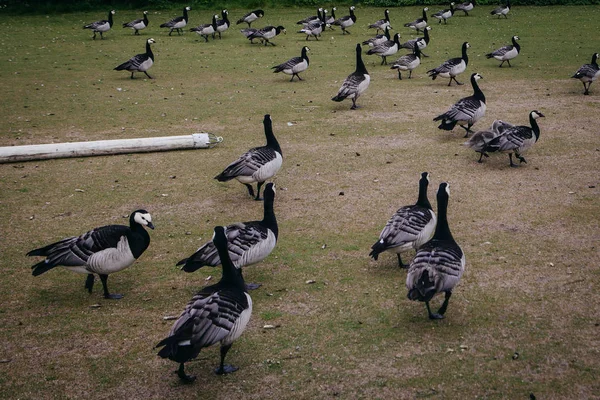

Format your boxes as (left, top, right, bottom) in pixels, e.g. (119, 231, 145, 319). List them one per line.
(406, 182, 465, 319)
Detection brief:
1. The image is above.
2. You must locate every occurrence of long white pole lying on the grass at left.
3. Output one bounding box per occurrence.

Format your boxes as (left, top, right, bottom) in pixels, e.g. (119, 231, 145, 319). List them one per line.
(0, 133, 223, 164)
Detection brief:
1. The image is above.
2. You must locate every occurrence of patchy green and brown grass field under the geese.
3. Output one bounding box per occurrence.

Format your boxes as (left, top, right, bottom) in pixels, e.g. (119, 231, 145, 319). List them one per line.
(0, 6, 600, 399)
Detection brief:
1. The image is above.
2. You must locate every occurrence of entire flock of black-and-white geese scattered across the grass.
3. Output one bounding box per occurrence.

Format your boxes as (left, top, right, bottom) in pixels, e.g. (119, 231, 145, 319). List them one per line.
(27, 2, 600, 382)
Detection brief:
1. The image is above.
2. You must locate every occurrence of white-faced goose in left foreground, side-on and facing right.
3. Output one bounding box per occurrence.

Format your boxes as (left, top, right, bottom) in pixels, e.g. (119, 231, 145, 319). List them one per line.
(27, 210, 154, 300)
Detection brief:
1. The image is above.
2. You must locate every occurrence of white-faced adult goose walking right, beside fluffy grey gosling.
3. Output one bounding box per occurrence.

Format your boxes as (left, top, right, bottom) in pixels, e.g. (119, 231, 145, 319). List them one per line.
(483, 110, 544, 167)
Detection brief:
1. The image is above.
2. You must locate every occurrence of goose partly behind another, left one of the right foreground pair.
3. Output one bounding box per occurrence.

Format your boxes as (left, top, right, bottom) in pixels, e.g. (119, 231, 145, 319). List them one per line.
(369, 172, 436, 268)
